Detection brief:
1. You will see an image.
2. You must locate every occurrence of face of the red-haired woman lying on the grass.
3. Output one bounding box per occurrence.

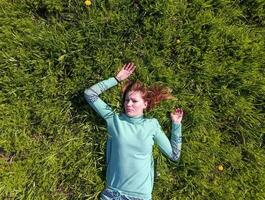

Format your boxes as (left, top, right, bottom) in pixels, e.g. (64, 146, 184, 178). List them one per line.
(124, 91, 147, 117)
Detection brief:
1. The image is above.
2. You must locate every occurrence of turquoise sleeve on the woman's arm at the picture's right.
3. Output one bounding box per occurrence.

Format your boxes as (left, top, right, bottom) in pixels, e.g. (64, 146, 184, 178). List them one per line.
(154, 119, 182, 161)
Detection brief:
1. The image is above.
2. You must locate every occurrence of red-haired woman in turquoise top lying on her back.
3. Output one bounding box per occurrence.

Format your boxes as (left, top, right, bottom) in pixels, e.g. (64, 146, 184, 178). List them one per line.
(84, 63, 183, 200)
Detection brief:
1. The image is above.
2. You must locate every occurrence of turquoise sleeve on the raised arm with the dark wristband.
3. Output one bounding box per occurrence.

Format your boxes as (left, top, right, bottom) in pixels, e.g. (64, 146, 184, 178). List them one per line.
(84, 77, 118, 122)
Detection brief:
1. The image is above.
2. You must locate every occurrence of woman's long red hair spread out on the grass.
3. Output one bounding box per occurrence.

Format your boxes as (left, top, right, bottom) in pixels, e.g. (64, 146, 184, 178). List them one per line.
(122, 80, 175, 111)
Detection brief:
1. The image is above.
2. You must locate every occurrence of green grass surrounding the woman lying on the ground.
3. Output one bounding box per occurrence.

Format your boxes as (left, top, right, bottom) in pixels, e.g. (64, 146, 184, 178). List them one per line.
(0, 0, 265, 200)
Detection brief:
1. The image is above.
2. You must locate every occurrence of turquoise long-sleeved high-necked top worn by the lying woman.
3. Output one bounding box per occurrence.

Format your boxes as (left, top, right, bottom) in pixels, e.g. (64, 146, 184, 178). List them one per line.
(85, 77, 181, 199)
